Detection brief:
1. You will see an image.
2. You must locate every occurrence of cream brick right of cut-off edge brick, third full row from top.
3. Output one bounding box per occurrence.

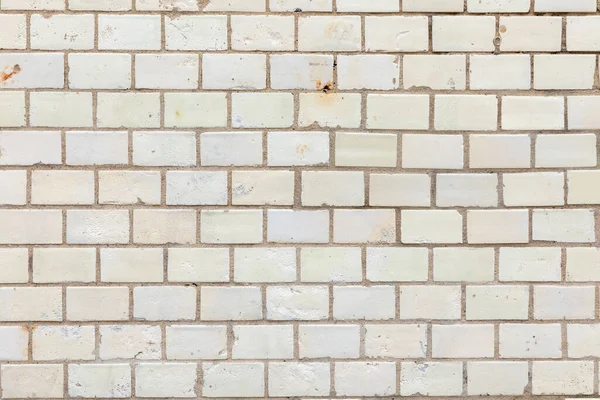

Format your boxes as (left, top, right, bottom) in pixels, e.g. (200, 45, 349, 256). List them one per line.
(29, 92, 92, 128)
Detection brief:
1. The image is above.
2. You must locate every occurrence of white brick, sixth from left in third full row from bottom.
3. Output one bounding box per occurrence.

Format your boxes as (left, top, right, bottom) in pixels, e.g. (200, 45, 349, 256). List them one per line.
(333, 286, 396, 320)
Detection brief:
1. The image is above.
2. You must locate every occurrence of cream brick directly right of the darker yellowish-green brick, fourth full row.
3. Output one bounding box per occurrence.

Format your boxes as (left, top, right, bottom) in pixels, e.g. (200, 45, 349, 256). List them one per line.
(402, 134, 464, 169)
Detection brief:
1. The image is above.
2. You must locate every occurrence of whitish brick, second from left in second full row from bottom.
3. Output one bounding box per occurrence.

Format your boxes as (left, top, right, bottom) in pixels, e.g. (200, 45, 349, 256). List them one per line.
(32, 325, 96, 360)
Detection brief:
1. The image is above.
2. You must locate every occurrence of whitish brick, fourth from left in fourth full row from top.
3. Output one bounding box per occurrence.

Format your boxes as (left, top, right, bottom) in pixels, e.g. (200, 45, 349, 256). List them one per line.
(200, 131, 263, 166)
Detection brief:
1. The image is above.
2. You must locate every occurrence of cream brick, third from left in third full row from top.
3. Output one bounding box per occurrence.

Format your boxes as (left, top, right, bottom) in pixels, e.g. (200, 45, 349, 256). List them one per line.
(96, 92, 160, 128)
